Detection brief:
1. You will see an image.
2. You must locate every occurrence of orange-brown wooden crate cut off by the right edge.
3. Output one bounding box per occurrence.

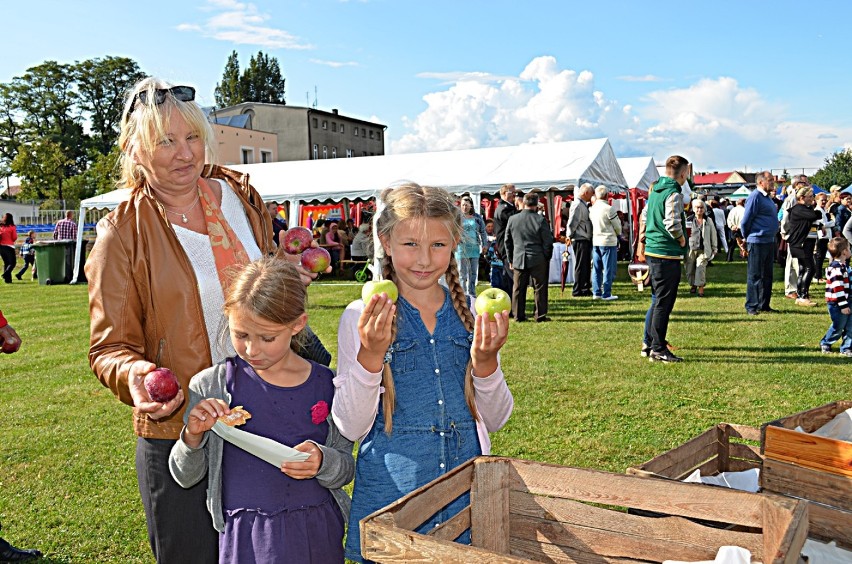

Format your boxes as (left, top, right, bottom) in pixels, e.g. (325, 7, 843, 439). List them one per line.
(760, 401, 852, 547)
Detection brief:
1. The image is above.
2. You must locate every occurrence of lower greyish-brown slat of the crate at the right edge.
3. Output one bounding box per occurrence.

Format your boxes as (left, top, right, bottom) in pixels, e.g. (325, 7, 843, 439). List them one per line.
(760, 458, 852, 511)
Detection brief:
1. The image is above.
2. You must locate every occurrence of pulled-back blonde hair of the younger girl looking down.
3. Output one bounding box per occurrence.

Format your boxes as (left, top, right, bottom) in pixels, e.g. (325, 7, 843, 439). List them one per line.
(222, 257, 308, 348)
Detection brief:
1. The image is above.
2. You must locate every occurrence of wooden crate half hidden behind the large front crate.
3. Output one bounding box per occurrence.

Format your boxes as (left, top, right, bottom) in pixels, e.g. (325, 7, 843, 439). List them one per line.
(627, 423, 763, 480)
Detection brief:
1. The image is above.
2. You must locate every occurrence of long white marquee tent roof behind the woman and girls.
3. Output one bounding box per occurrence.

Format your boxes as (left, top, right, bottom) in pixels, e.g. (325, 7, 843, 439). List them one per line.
(74, 138, 628, 281)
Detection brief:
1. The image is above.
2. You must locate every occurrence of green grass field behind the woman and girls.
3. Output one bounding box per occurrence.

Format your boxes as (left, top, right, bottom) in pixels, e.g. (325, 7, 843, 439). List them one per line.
(0, 262, 852, 563)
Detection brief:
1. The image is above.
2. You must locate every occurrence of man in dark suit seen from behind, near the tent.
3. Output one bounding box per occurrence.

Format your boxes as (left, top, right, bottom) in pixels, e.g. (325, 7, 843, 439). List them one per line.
(505, 193, 553, 323)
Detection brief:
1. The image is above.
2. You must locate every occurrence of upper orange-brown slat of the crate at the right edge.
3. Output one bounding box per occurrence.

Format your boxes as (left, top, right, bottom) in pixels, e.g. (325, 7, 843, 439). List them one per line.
(763, 425, 852, 478)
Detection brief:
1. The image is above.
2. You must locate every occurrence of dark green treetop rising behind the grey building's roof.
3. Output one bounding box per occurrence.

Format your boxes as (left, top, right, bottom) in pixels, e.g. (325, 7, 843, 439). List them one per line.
(215, 51, 286, 107)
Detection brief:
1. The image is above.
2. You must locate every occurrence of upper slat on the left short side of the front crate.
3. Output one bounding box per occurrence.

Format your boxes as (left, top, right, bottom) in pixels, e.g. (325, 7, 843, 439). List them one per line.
(362, 460, 473, 531)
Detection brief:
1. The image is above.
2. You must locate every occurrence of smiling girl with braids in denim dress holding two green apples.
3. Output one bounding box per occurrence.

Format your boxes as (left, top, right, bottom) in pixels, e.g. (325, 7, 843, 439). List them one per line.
(332, 183, 513, 562)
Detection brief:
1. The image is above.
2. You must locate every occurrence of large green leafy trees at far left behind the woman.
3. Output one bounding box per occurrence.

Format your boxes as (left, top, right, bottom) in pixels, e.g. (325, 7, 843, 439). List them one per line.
(0, 57, 145, 204)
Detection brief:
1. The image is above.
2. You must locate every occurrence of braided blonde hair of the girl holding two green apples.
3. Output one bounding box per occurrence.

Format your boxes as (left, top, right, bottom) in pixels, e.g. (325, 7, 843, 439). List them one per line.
(376, 182, 479, 435)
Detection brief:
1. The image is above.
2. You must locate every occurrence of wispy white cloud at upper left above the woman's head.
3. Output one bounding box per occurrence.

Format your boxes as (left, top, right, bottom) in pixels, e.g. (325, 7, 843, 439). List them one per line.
(177, 0, 314, 50)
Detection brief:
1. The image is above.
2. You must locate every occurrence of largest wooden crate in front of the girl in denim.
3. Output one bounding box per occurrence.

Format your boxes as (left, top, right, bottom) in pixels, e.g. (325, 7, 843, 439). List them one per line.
(360, 456, 807, 564)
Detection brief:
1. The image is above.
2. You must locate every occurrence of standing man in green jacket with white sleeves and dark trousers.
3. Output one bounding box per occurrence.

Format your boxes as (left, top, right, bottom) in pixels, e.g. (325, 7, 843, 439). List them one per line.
(645, 155, 689, 362)
